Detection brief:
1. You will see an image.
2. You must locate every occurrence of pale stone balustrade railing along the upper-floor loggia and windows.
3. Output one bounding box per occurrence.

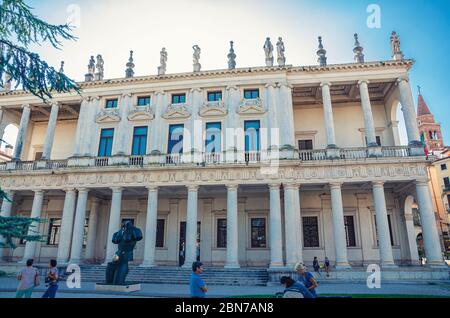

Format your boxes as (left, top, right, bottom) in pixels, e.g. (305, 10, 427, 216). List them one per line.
(0, 146, 422, 171)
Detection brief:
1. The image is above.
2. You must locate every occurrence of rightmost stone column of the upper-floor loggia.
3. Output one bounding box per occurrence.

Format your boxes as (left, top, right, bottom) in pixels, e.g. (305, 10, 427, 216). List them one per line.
(397, 78, 423, 147)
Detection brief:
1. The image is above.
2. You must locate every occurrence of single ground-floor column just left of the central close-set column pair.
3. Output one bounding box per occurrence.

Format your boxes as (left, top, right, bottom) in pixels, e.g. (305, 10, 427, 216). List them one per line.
(225, 184, 240, 268)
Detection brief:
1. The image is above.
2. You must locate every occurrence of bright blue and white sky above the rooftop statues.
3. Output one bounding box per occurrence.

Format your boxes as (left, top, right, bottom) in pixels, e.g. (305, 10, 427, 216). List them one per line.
(23, 0, 450, 145)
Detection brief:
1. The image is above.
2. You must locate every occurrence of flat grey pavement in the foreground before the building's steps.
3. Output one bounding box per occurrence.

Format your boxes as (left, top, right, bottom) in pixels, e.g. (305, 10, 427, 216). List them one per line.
(0, 278, 450, 298)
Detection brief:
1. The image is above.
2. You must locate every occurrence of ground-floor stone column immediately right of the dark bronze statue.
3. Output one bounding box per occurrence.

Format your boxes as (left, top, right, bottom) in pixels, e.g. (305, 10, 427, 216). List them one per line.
(141, 186, 158, 267)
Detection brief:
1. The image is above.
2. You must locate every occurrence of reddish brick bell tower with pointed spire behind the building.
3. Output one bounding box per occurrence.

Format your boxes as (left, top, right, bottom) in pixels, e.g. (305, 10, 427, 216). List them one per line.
(417, 86, 444, 152)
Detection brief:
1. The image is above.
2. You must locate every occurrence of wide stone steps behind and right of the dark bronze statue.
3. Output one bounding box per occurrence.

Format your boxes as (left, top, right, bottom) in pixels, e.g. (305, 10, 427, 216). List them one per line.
(61, 265, 269, 286)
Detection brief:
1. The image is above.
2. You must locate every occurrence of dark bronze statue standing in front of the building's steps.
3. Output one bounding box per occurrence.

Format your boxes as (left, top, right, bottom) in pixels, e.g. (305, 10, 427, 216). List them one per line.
(106, 221, 142, 285)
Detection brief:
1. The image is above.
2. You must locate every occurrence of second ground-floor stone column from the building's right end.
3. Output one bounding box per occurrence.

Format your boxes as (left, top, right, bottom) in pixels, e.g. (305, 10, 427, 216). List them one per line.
(372, 182, 395, 267)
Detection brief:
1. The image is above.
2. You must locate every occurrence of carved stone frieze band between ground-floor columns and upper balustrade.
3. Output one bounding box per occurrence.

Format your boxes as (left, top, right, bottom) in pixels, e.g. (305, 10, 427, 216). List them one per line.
(0, 163, 427, 190)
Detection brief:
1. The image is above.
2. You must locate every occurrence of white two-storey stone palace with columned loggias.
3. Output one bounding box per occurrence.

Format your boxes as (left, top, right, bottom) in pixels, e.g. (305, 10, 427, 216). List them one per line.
(0, 34, 444, 274)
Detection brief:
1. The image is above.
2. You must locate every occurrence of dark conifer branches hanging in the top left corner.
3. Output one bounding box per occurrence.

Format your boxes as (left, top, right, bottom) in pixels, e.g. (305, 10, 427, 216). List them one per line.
(0, 0, 80, 100)
